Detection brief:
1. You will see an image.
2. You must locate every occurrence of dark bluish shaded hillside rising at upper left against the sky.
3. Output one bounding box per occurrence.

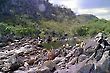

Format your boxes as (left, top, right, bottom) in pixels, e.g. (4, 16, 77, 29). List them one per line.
(0, 0, 75, 20)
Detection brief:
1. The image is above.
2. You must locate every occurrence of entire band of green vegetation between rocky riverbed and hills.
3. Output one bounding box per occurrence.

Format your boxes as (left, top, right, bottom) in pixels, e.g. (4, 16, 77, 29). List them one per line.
(0, 18, 110, 38)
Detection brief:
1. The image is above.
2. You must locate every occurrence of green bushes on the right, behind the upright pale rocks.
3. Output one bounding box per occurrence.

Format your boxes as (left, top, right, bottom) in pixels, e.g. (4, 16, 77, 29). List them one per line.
(76, 19, 110, 36)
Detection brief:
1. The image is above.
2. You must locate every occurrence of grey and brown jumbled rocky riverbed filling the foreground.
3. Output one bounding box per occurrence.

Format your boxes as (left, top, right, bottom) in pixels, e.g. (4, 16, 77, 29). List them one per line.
(0, 39, 110, 73)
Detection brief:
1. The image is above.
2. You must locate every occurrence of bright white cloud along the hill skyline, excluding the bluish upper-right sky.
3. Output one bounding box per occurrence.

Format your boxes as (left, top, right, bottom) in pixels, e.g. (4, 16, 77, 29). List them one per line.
(50, 0, 110, 19)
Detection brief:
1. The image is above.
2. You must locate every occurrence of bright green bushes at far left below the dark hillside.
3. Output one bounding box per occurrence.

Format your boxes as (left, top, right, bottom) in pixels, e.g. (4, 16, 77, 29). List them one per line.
(0, 23, 38, 37)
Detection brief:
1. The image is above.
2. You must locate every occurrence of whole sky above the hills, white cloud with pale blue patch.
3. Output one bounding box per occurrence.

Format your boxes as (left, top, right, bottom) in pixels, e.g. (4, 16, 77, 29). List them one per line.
(49, 0, 110, 20)
